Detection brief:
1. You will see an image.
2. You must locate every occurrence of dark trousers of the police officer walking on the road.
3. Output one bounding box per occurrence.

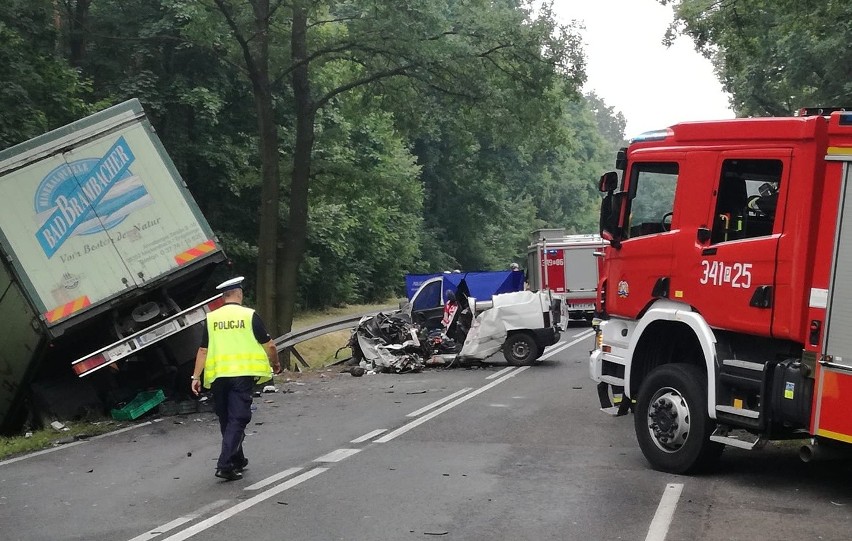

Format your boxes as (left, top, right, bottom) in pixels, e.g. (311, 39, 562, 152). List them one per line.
(211, 376, 254, 470)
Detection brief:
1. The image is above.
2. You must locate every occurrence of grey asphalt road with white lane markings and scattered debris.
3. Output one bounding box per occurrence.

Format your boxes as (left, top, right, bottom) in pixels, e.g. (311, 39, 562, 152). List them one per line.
(0, 327, 852, 541)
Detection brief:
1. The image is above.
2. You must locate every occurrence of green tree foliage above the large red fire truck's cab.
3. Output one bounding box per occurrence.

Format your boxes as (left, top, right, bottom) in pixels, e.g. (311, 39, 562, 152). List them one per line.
(660, 0, 852, 116)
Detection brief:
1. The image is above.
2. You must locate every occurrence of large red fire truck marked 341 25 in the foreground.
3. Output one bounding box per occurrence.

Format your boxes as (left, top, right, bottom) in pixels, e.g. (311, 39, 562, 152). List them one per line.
(590, 109, 852, 473)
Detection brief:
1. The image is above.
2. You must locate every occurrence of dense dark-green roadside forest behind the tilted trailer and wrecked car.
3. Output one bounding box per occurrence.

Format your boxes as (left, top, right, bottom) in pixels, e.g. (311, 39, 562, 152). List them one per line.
(0, 0, 624, 332)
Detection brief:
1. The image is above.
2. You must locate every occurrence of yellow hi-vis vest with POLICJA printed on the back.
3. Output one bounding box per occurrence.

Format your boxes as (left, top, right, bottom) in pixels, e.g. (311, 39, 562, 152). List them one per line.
(204, 304, 272, 388)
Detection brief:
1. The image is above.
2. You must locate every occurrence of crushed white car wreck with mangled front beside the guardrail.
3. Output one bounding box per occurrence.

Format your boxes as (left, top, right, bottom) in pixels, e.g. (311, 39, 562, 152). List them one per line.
(349, 273, 560, 373)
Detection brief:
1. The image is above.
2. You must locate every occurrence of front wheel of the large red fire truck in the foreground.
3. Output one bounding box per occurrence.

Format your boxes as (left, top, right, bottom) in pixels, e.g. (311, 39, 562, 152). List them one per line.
(634, 364, 724, 474)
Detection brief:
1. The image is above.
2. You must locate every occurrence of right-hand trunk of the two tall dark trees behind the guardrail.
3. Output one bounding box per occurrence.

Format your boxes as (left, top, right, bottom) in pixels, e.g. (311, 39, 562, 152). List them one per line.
(278, 2, 316, 342)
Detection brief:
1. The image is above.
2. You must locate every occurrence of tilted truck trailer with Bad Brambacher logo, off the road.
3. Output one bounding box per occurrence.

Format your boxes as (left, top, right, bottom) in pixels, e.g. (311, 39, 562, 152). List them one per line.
(0, 99, 225, 433)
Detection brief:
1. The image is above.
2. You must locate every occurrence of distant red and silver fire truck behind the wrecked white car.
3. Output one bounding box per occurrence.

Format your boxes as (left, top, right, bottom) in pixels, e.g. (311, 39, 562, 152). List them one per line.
(527, 229, 607, 321)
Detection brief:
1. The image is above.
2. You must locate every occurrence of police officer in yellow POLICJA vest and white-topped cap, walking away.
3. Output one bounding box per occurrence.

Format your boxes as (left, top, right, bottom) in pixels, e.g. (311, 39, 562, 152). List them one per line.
(192, 276, 281, 481)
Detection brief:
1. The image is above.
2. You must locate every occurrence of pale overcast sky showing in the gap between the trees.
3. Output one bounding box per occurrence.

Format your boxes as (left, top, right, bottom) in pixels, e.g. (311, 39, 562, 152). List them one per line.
(555, 0, 734, 139)
